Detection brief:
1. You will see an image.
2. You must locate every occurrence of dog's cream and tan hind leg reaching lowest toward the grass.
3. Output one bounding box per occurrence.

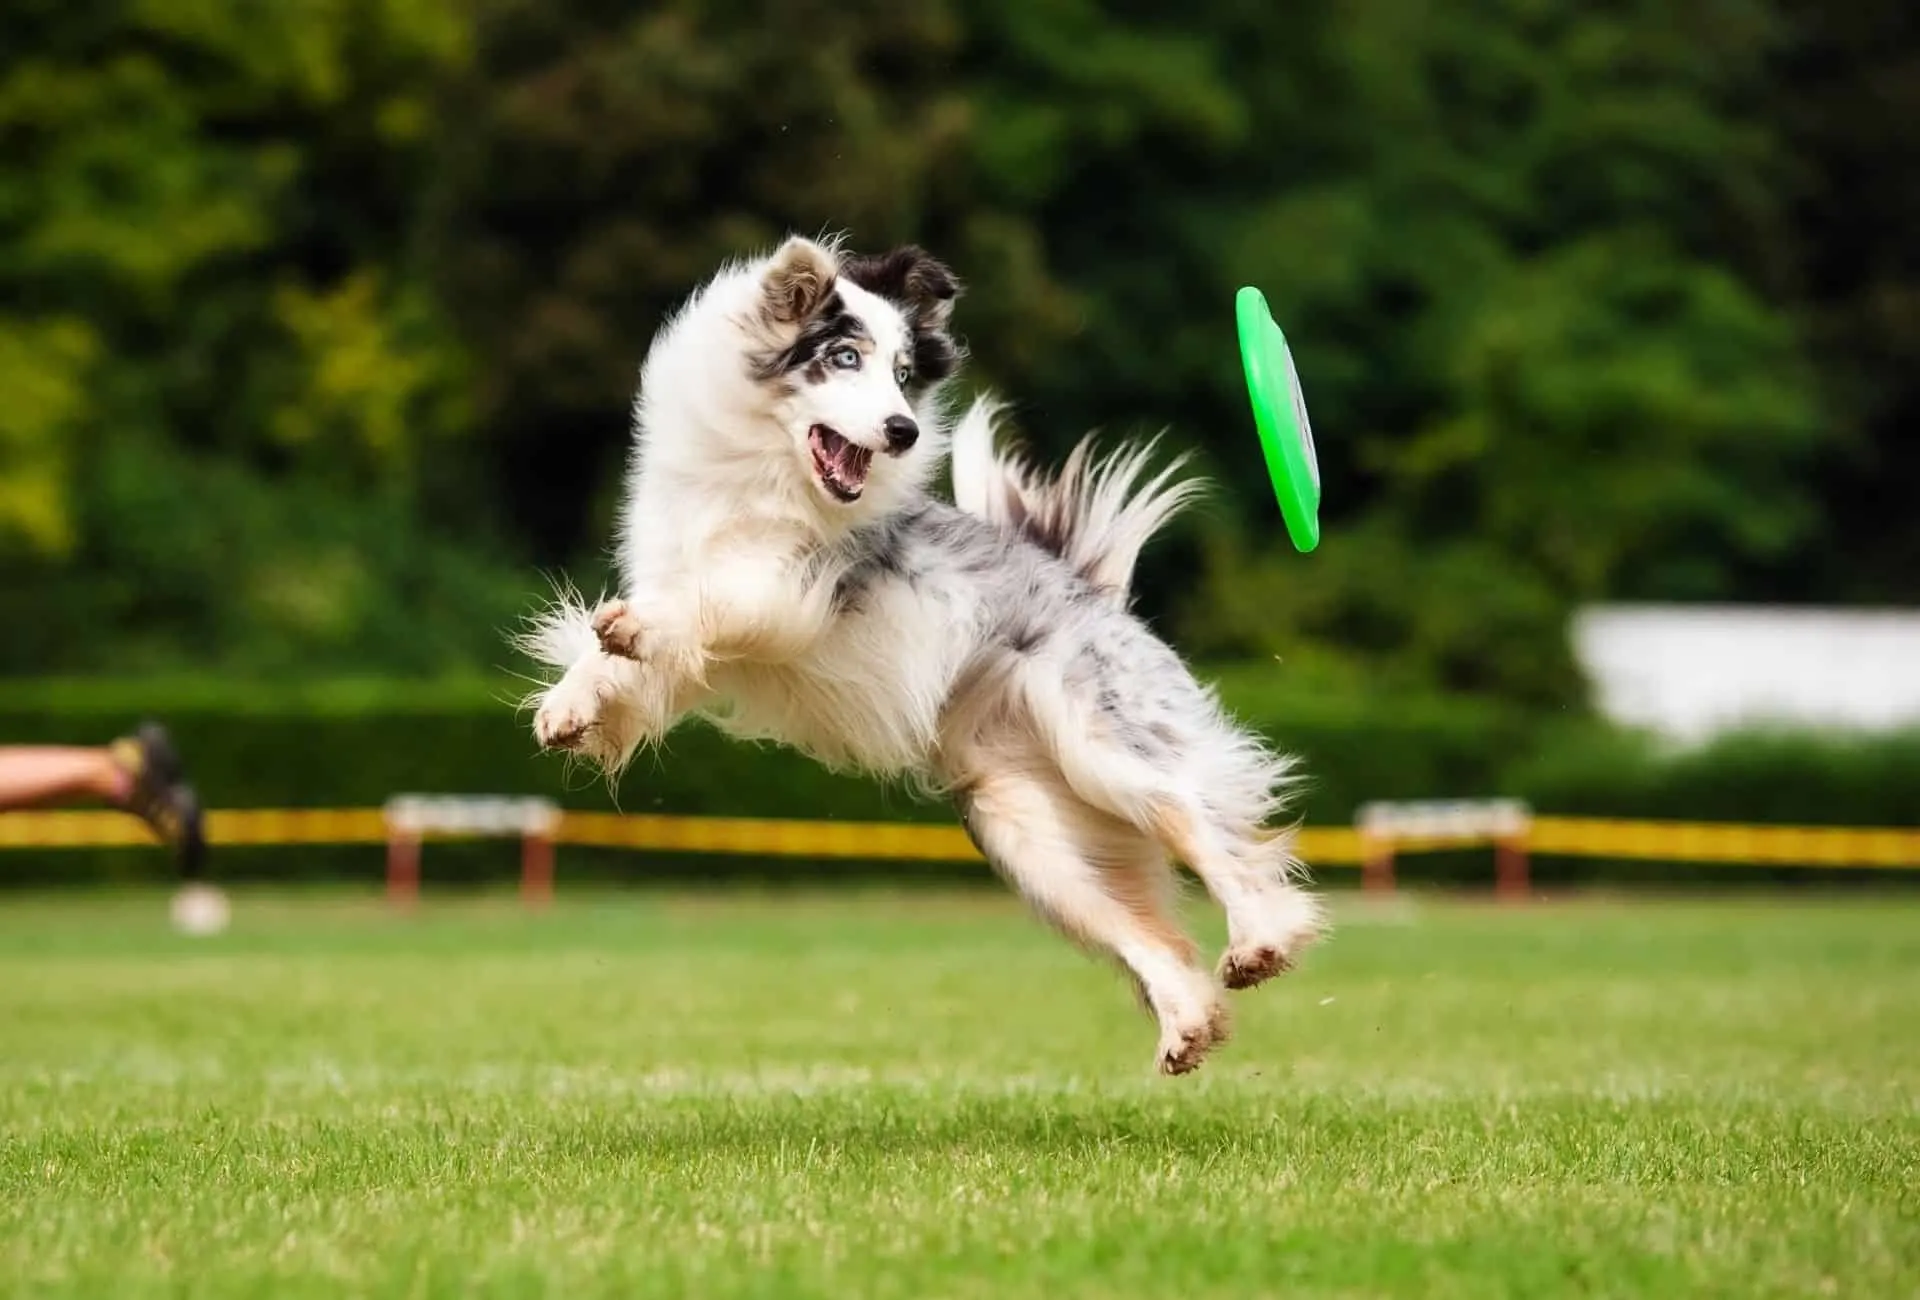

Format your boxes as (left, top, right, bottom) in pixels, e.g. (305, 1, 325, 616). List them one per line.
(960, 760, 1229, 1073)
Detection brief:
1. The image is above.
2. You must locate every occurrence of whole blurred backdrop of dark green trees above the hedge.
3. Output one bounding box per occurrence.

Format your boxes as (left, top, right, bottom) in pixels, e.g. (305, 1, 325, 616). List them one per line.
(0, 0, 1920, 707)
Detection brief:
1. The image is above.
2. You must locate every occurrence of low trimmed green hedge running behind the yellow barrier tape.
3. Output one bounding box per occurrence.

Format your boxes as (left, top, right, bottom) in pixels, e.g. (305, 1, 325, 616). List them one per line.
(0, 666, 1920, 881)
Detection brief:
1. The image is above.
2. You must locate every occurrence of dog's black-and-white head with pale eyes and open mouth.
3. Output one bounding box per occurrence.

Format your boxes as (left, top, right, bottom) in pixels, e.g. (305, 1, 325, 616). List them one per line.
(753, 238, 960, 513)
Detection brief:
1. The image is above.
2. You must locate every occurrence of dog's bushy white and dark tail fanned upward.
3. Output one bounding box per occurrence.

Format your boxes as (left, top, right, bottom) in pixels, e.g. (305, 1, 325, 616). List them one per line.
(952, 397, 1206, 605)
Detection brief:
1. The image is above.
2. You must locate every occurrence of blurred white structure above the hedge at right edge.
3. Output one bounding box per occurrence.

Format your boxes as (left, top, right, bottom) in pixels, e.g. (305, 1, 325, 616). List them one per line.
(1572, 605, 1920, 741)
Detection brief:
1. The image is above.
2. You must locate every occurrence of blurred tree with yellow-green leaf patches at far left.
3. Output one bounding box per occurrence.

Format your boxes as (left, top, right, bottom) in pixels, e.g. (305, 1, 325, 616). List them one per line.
(0, 0, 526, 670)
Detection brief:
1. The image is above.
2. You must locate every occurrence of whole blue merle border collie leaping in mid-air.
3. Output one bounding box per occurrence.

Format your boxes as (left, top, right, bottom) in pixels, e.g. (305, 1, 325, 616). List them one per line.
(522, 238, 1321, 1073)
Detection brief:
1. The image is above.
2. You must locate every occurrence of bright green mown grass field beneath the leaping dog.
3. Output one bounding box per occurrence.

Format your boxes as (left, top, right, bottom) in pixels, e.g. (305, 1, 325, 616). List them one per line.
(0, 893, 1920, 1300)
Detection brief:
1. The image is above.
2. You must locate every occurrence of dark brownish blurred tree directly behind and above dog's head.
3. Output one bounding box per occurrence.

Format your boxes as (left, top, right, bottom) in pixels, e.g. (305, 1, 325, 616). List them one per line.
(434, 0, 1090, 563)
